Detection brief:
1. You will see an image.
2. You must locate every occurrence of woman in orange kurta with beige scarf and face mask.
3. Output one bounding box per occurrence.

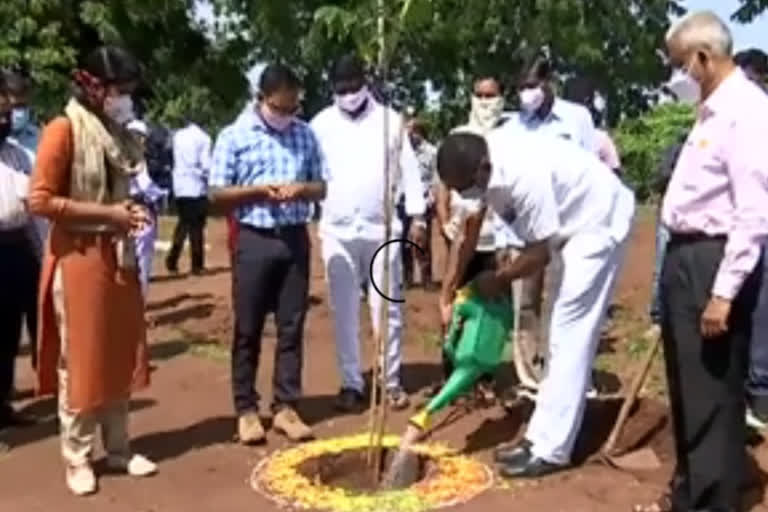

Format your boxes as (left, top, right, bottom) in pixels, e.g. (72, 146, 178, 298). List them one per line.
(28, 47, 156, 495)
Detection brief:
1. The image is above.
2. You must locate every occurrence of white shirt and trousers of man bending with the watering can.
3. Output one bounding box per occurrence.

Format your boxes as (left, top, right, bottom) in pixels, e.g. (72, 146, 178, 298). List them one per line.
(480, 131, 635, 464)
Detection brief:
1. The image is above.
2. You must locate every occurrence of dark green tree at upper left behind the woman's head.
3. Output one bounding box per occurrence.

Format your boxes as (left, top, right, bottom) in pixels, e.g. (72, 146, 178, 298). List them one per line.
(0, 0, 248, 128)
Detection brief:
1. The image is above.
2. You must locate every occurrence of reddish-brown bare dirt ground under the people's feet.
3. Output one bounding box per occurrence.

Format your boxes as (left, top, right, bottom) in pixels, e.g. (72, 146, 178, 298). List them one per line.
(0, 214, 768, 512)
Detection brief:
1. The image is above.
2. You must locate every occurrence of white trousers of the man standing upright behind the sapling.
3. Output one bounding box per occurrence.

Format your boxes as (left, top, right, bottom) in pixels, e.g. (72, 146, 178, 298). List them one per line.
(322, 233, 403, 392)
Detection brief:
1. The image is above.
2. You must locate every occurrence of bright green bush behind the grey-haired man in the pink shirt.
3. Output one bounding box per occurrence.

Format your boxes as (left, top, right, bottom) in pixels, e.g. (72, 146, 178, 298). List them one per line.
(614, 103, 695, 201)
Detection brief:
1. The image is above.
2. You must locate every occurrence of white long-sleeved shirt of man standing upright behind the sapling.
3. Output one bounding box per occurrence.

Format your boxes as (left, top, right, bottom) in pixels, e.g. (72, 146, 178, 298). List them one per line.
(310, 103, 426, 240)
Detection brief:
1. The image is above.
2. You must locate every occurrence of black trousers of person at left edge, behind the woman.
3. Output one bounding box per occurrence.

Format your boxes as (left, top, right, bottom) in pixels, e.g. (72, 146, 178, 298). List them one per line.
(0, 229, 40, 420)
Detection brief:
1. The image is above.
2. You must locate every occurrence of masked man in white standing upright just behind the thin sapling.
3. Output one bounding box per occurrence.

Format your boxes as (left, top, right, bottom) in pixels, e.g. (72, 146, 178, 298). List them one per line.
(311, 56, 426, 411)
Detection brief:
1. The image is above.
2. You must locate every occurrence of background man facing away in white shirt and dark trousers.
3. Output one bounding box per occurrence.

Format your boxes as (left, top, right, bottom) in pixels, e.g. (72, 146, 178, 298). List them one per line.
(165, 116, 211, 275)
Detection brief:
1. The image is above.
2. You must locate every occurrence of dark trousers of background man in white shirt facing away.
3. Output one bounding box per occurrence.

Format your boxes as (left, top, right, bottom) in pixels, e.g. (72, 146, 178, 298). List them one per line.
(166, 197, 208, 271)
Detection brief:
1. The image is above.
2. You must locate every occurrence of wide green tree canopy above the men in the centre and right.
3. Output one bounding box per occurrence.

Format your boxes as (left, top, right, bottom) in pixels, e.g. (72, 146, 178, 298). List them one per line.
(214, 0, 682, 131)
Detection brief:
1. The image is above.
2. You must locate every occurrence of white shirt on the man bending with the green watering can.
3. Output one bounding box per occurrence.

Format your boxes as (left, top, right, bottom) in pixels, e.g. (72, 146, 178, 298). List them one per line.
(473, 130, 635, 247)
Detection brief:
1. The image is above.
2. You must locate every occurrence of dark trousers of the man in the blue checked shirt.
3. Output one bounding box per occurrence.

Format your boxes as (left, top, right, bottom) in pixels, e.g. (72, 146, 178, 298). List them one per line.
(232, 224, 310, 415)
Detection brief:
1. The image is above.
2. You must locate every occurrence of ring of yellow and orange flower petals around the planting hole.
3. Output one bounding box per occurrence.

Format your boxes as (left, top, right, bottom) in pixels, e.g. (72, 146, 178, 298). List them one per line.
(251, 434, 494, 512)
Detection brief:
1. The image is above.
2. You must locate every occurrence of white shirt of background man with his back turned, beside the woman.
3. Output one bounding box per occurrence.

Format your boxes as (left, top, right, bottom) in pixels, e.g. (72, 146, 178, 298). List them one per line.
(173, 124, 211, 198)
